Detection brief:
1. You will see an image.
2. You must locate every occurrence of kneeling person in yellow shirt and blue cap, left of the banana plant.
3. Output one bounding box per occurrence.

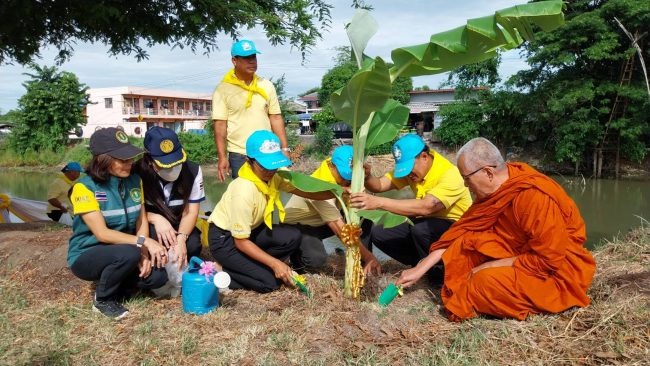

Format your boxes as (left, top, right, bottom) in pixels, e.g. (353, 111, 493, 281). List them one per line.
(208, 130, 332, 292)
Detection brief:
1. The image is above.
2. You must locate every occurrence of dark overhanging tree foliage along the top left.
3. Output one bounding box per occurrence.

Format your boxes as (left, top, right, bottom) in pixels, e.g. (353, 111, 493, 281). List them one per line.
(0, 0, 332, 65)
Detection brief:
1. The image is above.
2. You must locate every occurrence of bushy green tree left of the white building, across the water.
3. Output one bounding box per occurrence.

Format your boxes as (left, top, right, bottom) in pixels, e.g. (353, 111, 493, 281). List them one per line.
(9, 64, 89, 153)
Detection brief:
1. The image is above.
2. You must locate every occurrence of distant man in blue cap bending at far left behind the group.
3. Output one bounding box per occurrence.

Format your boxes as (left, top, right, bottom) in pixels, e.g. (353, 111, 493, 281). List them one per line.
(46, 161, 83, 222)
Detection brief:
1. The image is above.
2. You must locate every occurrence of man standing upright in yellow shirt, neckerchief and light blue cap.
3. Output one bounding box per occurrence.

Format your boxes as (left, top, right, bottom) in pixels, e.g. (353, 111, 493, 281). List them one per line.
(212, 40, 289, 182)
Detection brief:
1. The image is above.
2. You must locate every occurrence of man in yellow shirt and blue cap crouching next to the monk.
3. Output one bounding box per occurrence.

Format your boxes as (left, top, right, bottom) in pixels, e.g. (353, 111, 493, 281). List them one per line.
(350, 134, 472, 281)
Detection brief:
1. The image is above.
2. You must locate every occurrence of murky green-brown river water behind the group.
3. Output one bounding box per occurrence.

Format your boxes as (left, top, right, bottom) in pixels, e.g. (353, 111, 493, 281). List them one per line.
(0, 168, 650, 250)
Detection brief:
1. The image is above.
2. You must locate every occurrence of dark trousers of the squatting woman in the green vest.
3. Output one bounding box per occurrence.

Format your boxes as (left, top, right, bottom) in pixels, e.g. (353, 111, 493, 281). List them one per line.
(70, 244, 167, 300)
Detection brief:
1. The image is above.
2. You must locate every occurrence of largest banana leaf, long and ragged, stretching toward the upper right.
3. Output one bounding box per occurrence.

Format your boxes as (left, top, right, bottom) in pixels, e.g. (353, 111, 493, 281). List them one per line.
(390, 0, 564, 79)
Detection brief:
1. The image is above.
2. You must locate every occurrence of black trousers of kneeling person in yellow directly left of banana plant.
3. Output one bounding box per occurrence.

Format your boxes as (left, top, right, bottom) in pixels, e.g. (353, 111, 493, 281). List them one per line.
(208, 223, 300, 293)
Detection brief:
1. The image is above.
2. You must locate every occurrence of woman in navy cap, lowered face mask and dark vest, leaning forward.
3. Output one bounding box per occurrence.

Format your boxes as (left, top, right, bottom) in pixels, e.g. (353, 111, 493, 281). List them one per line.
(135, 127, 205, 268)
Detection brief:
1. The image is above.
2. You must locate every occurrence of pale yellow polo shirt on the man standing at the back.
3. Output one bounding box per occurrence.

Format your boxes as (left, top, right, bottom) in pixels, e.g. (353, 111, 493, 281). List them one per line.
(212, 77, 281, 155)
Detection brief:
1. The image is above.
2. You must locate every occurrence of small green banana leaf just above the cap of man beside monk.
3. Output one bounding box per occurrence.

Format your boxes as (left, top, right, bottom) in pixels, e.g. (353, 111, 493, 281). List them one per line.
(366, 99, 410, 151)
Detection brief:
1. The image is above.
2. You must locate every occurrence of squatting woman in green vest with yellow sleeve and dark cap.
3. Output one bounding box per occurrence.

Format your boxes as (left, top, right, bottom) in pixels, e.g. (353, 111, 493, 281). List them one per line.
(68, 128, 167, 319)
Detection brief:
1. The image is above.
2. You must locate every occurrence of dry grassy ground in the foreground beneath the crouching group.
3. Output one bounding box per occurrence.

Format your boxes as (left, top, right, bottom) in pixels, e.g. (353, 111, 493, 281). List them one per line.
(0, 223, 650, 365)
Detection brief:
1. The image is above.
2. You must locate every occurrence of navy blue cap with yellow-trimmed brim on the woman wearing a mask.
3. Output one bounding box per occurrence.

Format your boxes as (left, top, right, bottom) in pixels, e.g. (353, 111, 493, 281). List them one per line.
(144, 126, 187, 168)
